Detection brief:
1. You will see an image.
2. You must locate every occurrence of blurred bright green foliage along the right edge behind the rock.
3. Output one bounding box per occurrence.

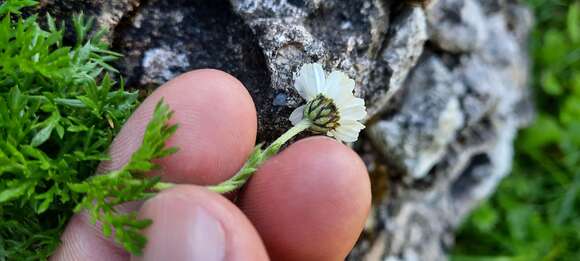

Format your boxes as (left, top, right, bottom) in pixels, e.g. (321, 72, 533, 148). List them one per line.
(452, 0, 580, 261)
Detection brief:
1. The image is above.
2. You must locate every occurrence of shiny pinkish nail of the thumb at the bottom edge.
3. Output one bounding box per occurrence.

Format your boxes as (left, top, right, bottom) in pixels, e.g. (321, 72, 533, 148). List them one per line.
(134, 207, 226, 261)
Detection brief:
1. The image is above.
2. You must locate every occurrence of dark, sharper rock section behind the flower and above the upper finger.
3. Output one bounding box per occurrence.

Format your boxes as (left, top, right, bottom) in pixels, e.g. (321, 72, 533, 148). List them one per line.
(114, 0, 427, 141)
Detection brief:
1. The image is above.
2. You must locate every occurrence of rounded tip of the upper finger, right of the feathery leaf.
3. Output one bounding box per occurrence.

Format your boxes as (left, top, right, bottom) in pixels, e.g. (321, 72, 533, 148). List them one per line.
(160, 69, 257, 185)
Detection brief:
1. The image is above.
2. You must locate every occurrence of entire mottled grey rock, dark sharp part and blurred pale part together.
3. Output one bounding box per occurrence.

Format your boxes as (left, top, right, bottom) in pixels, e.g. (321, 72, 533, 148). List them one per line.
(43, 0, 533, 260)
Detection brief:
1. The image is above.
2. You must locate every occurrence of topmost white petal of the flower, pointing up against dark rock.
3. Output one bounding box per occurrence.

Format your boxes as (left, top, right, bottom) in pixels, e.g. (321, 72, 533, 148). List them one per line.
(294, 63, 326, 101)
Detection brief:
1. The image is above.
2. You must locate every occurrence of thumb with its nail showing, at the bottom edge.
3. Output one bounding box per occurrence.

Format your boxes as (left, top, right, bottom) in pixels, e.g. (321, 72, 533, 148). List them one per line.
(133, 185, 268, 261)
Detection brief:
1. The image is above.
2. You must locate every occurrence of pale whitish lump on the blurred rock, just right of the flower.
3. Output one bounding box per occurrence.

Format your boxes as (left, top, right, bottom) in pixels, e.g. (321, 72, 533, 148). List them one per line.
(368, 57, 463, 179)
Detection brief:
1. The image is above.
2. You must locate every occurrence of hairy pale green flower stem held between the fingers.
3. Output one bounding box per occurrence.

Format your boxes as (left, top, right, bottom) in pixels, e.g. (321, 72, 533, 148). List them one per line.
(207, 119, 311, 194)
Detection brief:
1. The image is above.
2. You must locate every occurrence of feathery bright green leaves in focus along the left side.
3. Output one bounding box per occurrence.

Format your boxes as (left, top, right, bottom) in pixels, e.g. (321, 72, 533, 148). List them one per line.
(0, 0, 176, 260)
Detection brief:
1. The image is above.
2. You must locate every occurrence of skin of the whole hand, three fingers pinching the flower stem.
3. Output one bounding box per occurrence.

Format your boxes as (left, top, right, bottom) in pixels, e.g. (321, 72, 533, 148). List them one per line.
(51, 70, 371, 261)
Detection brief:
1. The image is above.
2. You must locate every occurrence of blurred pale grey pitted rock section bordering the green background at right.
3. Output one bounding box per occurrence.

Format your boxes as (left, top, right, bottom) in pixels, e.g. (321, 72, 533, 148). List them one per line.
(358, 0, 533, 260)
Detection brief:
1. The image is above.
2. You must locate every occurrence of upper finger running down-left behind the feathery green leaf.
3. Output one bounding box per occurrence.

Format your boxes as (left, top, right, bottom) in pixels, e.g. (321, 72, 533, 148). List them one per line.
(52, 70, 257, 260)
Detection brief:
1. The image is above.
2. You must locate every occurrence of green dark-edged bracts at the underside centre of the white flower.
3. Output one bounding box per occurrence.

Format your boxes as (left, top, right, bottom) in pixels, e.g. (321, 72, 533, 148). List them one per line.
(304, 94, 340, 133)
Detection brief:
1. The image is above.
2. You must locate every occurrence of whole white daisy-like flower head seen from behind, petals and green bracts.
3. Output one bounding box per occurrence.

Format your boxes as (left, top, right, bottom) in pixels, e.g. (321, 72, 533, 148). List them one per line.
(290, 63, 366, 142)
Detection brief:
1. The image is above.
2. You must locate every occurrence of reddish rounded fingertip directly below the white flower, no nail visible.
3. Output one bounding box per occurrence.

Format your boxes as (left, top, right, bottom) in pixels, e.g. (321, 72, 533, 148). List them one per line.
(239, 137, 371, 260)
